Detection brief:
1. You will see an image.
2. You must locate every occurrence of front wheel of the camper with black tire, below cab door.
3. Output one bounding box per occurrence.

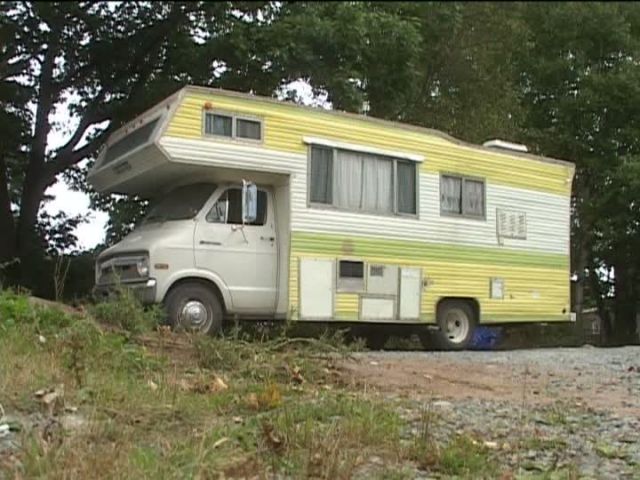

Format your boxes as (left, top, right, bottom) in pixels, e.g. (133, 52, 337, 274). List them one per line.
(164, 282, 224, 335)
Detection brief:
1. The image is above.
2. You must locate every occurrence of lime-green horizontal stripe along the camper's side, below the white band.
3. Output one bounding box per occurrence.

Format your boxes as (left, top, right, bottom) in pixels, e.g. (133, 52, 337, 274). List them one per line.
(291, 232, 569, 270)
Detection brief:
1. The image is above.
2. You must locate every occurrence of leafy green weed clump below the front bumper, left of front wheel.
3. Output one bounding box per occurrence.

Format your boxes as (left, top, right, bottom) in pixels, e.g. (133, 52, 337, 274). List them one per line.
(90, 288, 164, 333)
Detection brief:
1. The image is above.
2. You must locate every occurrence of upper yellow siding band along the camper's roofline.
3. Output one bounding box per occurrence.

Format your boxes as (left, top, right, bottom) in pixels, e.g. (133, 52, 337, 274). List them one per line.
(165, 93, 573, 195)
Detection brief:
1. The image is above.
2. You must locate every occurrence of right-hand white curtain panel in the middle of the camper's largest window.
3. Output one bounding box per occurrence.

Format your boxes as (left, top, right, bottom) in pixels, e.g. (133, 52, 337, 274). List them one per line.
(362, 155, 393, 213)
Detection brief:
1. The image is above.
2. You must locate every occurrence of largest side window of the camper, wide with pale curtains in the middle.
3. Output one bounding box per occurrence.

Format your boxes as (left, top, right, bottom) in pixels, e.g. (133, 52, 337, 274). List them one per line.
(309, 145, 418, 215)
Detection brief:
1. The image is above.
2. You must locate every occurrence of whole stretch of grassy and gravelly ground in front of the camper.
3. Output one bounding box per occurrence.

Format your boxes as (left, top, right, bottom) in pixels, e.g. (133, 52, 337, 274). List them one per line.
(0, 310, 640, 480)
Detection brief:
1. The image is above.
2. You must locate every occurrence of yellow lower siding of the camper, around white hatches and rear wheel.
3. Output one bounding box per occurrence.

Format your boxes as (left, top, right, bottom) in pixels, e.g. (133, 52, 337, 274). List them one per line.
(289, 232, 570, 323)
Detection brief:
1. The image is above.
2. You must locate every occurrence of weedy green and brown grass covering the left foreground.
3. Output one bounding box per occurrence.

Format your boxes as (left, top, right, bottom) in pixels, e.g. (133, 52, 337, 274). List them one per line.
(0, 291, 604, 480)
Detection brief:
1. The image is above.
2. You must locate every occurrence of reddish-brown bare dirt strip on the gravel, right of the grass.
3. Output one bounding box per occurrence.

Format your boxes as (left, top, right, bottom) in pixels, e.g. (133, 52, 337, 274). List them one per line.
(340, 352, 640, 415)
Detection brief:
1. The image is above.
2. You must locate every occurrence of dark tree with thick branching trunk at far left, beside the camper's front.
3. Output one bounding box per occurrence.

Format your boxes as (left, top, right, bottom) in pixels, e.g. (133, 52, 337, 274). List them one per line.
(0, 2, 272, 284)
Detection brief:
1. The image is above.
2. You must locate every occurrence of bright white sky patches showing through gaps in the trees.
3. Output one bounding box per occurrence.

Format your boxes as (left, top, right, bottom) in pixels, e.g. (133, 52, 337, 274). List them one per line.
(43, 81, 324, 249)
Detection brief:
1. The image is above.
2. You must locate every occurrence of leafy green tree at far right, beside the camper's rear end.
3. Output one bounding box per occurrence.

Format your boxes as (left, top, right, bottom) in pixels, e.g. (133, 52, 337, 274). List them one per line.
(519, 3, 640, 341)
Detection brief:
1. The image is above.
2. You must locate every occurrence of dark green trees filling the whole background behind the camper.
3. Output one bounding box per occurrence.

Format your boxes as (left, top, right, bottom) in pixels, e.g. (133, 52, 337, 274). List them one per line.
(0, 2, 640, 340)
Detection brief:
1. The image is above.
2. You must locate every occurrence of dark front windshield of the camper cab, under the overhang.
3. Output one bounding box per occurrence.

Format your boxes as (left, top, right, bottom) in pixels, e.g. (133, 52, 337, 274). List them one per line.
(143, 183, 216, 224)
